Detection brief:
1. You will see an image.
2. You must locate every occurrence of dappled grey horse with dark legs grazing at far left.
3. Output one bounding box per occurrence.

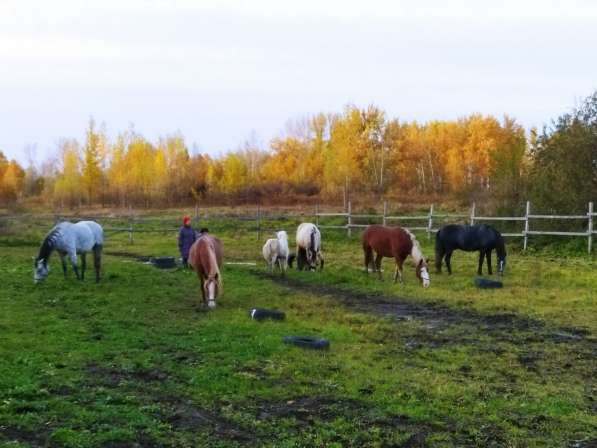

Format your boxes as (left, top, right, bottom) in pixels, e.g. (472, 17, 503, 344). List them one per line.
(33, 221, 104, 283)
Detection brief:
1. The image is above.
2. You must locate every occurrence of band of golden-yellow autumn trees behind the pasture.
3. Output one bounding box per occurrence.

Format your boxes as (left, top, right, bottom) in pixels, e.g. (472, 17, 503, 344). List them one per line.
(0, 92, 597, 212)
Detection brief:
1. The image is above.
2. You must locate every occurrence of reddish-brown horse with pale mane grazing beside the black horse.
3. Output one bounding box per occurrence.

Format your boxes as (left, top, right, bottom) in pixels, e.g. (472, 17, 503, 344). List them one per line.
(363, 224, 429, 288)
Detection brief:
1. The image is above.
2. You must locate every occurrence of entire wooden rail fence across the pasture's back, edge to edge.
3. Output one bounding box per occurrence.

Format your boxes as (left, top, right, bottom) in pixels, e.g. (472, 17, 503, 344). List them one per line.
(0, 201, 597, 254)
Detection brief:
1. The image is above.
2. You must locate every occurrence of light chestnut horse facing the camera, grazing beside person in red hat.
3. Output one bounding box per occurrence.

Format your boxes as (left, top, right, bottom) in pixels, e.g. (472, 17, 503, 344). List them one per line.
(189, 229, 223, 308)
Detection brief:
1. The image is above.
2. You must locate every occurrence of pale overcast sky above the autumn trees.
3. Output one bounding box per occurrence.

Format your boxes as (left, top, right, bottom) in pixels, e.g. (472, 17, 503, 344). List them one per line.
(0, 0, 597, 161)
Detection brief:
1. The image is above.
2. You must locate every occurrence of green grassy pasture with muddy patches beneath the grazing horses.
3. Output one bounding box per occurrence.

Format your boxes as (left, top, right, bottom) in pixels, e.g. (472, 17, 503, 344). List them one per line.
(0, 215, 597, 448)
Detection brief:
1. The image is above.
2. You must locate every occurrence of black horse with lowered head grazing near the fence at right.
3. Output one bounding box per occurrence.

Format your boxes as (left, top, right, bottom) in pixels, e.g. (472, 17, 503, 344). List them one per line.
(435, 224, 506, 275)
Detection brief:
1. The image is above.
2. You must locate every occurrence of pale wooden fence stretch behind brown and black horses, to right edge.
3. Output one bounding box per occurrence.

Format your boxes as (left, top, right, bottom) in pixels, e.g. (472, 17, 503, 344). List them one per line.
(315, 201, 597, 254)
